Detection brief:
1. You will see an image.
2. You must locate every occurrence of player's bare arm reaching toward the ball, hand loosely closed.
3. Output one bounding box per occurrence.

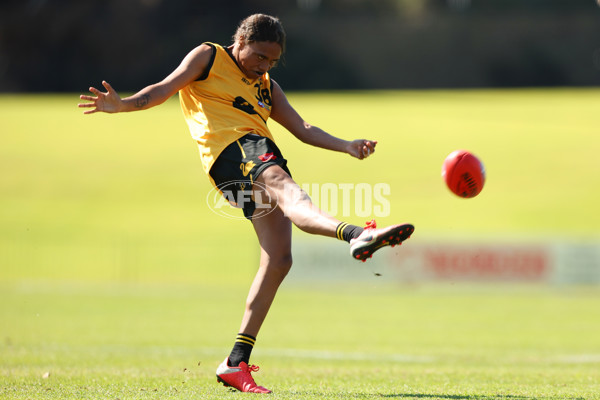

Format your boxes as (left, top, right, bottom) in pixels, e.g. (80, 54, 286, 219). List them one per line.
(271, 81, 377, 160)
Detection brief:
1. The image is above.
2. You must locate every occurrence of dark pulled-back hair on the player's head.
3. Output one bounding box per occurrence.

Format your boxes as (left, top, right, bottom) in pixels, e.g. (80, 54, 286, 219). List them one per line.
(233, 14, 285, 51)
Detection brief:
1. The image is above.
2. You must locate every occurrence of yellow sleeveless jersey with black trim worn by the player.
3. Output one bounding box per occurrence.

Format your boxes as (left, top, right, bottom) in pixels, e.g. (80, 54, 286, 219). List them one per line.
(179, 43, 273, 174)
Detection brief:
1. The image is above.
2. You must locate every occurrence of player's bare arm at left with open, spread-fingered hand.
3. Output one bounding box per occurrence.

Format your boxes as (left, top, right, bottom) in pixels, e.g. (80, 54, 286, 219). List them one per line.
(78, 44, 212, 114)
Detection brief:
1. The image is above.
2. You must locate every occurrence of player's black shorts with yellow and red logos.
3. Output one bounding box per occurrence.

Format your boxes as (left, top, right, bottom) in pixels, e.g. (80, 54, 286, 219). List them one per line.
(209, 133, 292, 220)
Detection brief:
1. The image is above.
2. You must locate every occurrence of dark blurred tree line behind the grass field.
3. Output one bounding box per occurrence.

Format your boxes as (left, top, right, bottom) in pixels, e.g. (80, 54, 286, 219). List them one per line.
(0, 0, 600, 92)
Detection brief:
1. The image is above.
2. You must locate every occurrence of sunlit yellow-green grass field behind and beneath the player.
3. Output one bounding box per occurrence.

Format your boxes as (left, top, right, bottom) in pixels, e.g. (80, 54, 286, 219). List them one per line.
(0, 89, 600, 400)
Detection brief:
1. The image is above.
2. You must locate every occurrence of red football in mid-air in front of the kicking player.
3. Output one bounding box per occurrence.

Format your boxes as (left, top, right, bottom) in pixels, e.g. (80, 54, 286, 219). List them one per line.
(442, 150, 485, 198)
